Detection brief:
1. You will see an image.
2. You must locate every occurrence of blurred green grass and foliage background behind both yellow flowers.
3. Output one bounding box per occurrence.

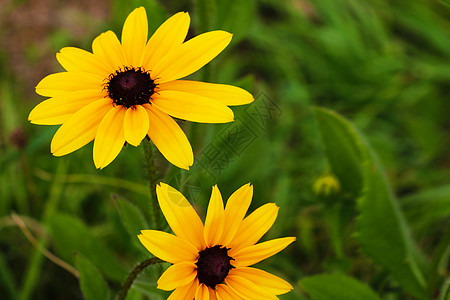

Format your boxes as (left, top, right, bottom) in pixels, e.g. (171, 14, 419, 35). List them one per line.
(0, 0, 450, 300)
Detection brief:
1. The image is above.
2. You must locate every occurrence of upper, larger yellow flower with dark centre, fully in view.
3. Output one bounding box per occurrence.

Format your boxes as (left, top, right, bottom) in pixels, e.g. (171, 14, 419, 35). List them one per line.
(28, 7, 254, 169)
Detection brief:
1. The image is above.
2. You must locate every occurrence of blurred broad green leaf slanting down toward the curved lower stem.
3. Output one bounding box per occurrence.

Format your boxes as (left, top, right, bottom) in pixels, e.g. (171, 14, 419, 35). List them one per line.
(49, 213, 127, 282)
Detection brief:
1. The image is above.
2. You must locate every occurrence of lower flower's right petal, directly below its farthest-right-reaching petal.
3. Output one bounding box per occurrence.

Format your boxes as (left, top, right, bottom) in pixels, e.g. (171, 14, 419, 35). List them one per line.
(230, 267, 294, 295)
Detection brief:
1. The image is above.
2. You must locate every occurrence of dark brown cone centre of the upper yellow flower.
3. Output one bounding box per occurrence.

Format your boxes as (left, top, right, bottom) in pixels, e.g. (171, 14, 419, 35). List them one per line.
(105, 67, 156, 108)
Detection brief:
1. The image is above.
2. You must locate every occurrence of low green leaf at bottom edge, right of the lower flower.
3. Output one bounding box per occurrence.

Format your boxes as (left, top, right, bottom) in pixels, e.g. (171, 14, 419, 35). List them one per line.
(300, 273, 381, 300)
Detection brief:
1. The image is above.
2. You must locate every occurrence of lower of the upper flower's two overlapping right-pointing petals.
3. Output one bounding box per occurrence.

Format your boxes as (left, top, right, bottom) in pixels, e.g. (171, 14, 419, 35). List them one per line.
(152, 91, 234, 123)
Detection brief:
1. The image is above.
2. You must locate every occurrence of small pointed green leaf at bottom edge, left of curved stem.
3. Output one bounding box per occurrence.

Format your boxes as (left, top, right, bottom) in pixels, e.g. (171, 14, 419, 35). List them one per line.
(75, 254, 109, 300)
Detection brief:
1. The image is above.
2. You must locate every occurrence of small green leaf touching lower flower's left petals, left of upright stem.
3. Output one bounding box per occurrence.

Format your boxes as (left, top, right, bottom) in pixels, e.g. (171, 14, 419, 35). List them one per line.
(114, 197, 149, 241)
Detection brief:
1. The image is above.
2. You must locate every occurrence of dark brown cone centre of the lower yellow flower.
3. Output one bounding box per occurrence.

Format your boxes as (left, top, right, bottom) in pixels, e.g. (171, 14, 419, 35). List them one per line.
(197, 245, 234, 289)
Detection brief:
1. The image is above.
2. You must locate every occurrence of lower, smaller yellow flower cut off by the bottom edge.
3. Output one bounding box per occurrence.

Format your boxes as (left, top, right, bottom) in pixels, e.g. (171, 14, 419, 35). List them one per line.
(138, 183, 295, 300)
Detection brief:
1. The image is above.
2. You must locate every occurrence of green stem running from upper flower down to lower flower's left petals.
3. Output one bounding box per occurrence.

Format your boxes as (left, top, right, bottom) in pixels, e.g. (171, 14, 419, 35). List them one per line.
(144, 139, 161, 229)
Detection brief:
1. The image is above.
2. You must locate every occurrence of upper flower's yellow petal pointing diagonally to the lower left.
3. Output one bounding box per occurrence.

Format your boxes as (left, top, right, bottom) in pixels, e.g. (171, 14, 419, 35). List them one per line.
(50, 99, 113, 156)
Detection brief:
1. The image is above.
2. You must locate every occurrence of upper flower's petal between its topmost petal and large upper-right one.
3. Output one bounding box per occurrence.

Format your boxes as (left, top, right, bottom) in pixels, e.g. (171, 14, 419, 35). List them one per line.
(141, 12, 191, 70)
